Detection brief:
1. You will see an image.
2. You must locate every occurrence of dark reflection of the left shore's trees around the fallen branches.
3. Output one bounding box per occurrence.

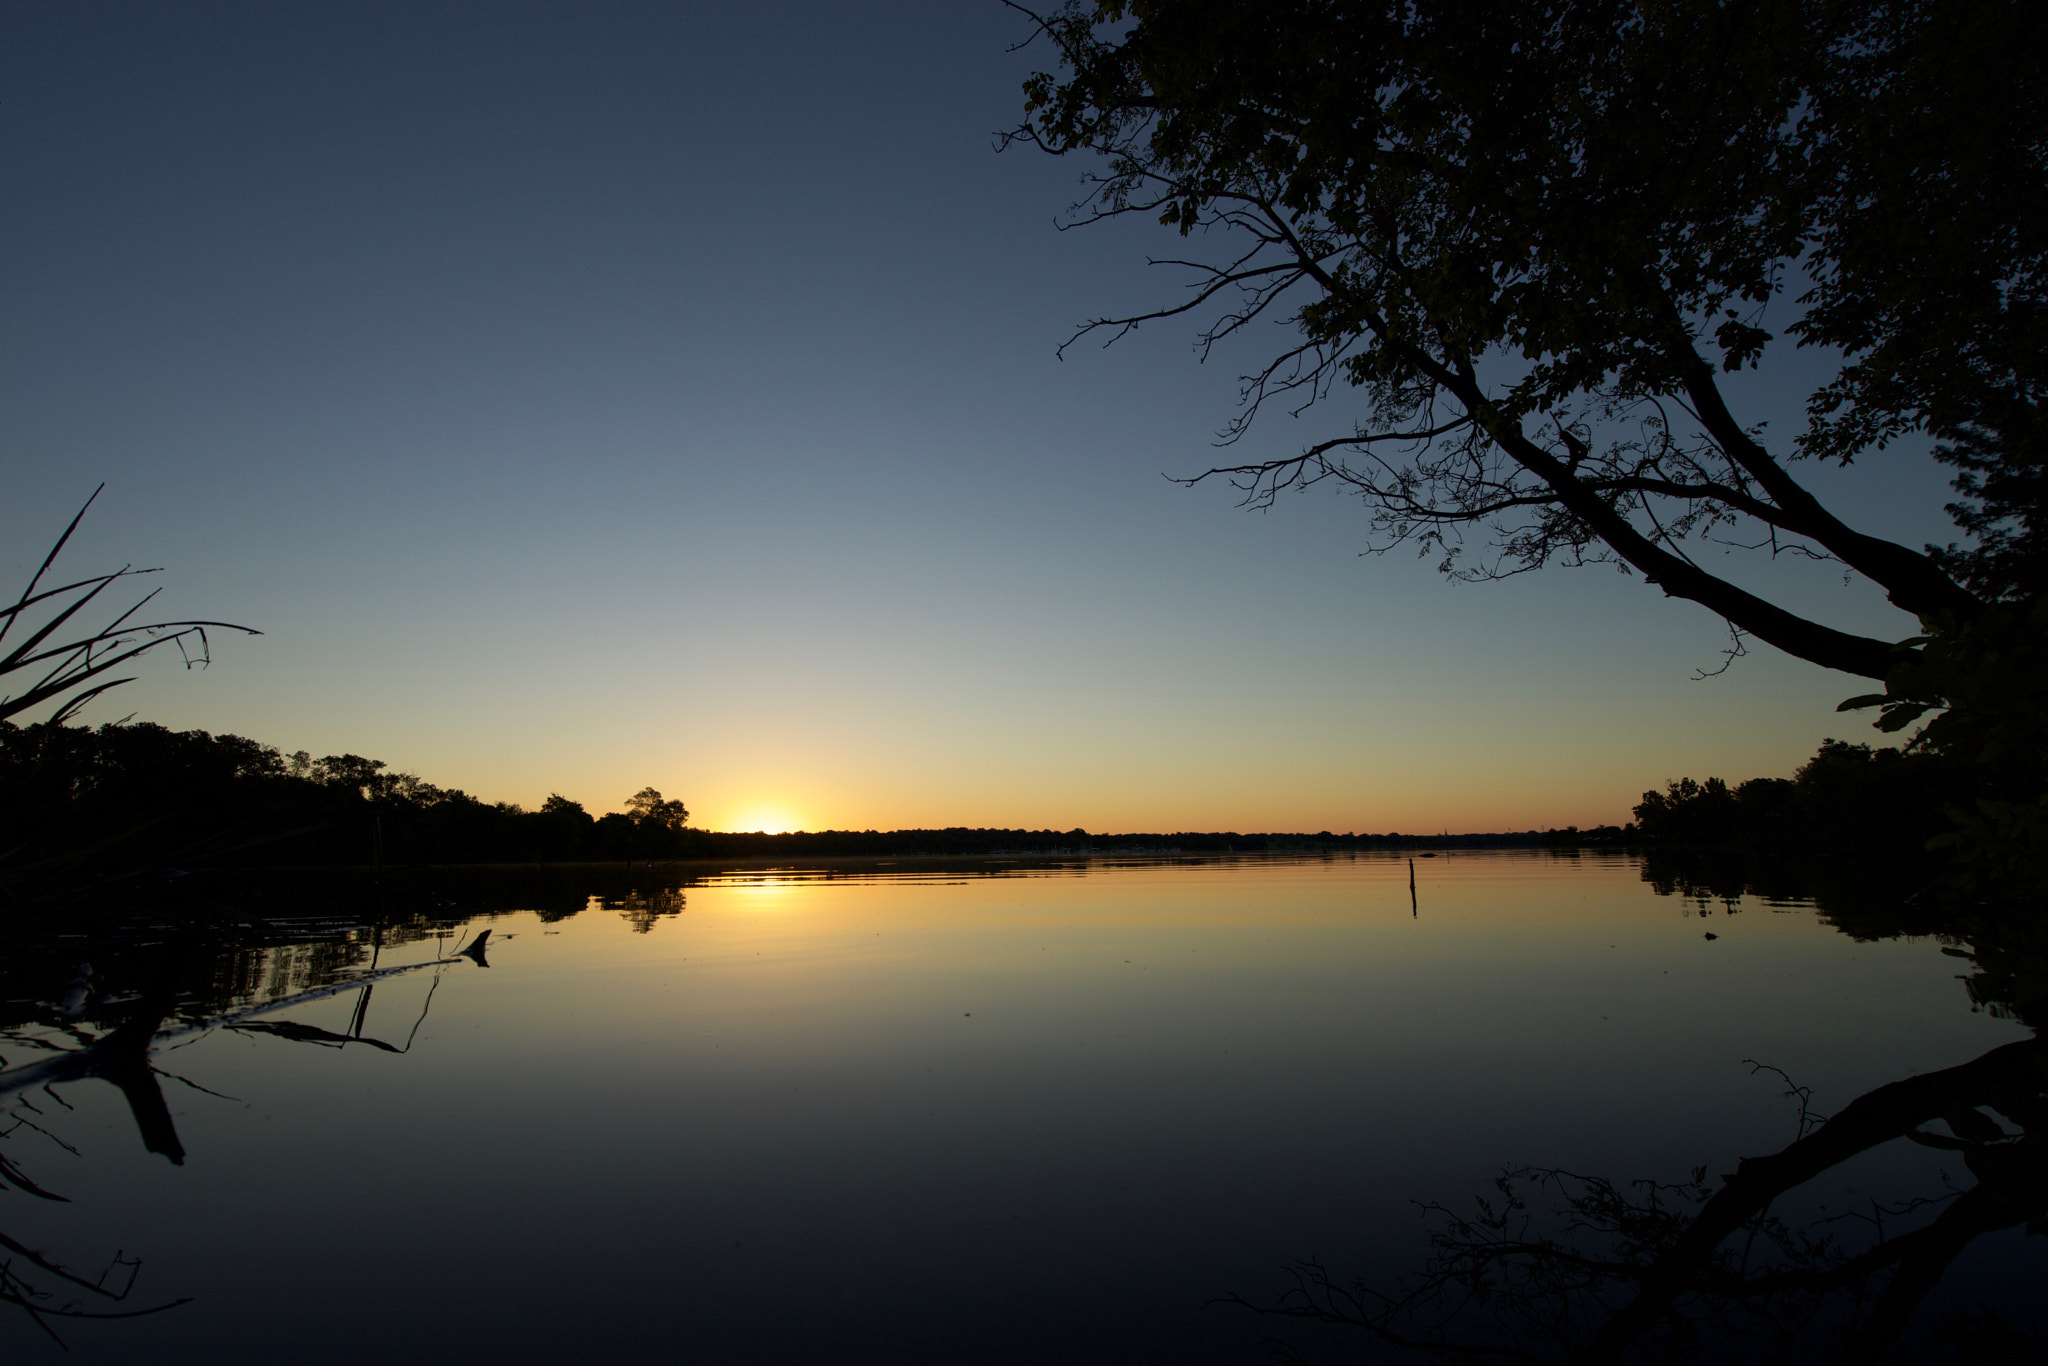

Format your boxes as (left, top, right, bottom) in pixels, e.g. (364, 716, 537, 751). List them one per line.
(0, 870, 704, 1341)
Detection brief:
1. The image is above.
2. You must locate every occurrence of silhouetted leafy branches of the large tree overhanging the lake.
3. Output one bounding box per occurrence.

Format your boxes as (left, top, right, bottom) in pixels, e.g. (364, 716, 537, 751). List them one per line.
(1010, 0, 2048, 678)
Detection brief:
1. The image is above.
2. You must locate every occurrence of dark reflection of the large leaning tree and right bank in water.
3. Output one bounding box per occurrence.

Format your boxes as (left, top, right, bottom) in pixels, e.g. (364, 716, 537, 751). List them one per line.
(1233, 880, 2048, 1364)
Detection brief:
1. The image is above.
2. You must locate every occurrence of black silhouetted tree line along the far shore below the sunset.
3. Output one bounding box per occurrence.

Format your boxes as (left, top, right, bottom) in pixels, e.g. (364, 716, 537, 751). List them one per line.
(0, 723, 1972, 885)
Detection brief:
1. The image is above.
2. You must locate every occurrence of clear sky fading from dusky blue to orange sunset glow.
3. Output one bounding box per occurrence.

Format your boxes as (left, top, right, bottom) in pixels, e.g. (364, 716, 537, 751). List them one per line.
(0, 0, 1954, 831)
